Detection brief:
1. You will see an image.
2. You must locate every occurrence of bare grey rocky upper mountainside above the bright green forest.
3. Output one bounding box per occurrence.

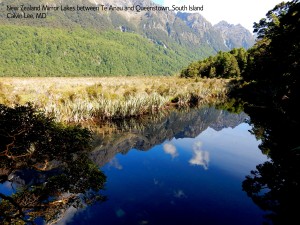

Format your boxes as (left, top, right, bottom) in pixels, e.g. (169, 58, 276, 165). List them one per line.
(0, 0, 254, 59)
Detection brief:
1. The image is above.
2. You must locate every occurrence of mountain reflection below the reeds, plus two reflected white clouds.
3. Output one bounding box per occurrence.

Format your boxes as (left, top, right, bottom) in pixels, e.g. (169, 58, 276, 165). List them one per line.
(90, 107, 249, 168)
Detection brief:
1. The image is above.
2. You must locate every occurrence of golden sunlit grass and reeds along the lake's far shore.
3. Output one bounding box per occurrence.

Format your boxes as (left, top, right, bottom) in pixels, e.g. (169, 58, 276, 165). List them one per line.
(0, 76, 232, 123)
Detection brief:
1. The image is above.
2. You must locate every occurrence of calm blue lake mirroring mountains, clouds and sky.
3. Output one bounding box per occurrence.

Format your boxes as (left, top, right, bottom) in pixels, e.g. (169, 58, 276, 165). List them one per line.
(0, 107, 276, 225)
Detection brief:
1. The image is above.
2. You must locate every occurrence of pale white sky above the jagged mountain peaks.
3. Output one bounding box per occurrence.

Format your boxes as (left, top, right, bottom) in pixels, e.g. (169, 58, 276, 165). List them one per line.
(153, 0, 282, 32)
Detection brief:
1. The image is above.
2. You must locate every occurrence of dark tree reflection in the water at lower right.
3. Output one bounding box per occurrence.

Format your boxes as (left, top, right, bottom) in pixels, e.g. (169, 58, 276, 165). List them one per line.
(243, 108, 300, 224)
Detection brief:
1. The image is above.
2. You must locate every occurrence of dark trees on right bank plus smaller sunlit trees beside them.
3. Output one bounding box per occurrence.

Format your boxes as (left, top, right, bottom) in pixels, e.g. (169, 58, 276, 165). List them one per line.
(180, 0, 300, 117)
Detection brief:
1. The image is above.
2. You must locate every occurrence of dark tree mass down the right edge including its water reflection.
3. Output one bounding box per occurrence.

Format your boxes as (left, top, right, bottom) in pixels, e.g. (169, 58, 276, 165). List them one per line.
(240, 0, 300, 221)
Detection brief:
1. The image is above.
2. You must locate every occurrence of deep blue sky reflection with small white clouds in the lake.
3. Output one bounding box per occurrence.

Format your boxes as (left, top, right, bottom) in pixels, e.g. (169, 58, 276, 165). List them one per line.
(67, 120, 267, 225)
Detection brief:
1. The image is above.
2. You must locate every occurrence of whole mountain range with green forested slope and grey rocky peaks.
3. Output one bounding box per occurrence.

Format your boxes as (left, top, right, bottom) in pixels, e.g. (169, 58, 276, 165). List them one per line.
(0, 0, 254, 76)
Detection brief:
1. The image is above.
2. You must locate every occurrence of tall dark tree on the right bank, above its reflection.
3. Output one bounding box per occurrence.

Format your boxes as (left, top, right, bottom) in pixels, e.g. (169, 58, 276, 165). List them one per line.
(243, 0, 300, 118)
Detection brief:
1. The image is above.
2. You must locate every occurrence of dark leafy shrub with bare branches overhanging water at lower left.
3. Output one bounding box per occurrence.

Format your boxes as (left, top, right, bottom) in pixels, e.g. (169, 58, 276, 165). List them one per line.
(0, 105, 106, 224)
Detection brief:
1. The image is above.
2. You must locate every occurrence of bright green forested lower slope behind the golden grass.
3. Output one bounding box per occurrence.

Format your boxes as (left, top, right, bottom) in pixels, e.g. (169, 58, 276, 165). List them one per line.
(0, 25, 213, 76)
